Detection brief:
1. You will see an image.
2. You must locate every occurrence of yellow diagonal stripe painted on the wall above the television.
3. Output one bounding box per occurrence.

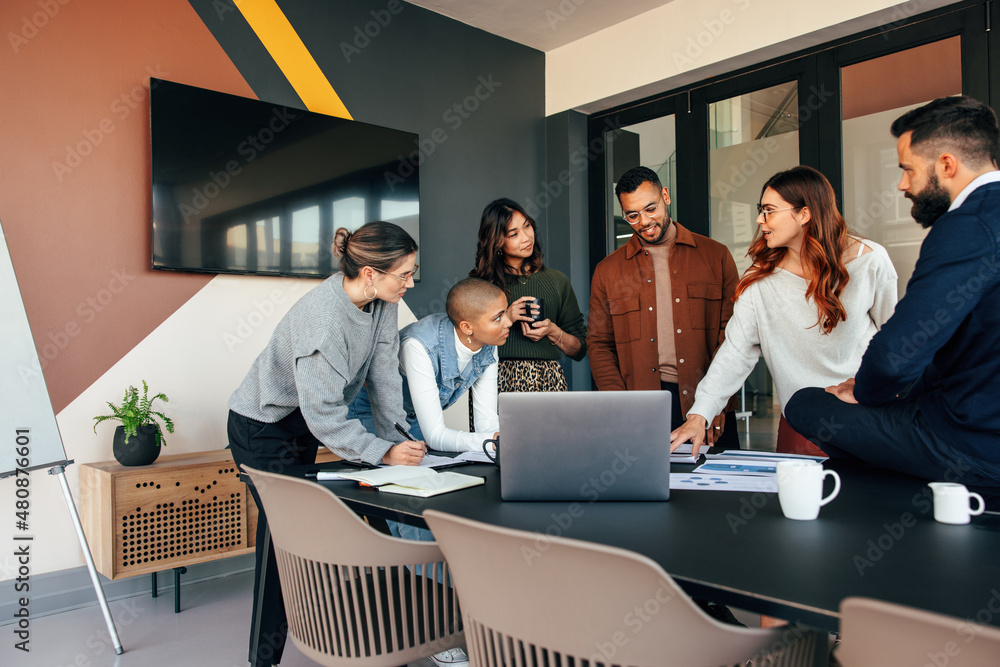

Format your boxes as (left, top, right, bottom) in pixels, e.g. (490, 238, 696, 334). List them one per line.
(236, 0, 351, 118)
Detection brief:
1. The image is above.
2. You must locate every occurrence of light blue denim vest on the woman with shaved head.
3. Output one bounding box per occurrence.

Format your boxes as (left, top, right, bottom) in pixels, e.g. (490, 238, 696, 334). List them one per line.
(399, 314, 496, 415)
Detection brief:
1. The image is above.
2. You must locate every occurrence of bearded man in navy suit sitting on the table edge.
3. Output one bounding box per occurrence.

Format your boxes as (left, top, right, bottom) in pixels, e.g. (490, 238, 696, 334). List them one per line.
(785, 96, 1000, 487)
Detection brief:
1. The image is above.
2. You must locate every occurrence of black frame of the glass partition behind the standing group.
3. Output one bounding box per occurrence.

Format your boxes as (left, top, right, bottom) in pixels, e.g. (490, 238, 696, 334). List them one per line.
(587, 0, 1000, 273)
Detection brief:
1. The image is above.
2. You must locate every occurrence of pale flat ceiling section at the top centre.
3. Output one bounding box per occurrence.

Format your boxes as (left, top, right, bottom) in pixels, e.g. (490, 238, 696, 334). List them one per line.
(407, 0, 671, 51)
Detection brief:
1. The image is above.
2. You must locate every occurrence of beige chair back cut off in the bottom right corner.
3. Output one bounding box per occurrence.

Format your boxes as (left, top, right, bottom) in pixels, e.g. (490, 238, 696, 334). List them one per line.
(835, 598, 1000, 667)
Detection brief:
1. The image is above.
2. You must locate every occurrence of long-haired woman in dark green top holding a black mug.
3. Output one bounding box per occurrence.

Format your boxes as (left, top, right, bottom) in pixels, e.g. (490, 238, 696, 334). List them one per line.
(469, 199, 587, 391)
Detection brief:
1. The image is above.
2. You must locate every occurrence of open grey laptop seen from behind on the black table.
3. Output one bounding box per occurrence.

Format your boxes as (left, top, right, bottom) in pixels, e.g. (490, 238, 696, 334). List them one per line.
(498, 391, 670, 503)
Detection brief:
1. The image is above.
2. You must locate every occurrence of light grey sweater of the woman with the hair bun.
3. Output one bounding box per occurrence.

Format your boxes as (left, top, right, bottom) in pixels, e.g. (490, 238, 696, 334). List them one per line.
(229, 273, 406, 463)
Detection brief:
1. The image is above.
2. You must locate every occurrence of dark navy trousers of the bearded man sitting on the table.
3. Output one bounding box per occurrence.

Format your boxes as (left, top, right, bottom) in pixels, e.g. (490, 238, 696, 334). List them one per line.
(785, 387, 1000, 487)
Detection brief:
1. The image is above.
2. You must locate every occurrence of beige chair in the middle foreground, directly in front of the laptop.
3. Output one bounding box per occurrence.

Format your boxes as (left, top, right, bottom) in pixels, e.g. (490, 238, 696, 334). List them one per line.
(423, 510, 829, 667)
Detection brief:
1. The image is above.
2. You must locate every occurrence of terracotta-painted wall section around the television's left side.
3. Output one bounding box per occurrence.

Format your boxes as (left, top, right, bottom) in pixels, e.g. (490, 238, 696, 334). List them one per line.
(0, 0, 254, 413)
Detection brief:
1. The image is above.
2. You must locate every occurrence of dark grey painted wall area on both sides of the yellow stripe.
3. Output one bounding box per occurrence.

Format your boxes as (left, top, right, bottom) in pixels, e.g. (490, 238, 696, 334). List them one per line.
(190, 0, 548, 317)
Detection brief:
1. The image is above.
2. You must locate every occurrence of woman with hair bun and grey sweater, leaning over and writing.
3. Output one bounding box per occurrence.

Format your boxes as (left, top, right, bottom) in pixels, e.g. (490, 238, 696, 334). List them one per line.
(228, 222, 425, 665)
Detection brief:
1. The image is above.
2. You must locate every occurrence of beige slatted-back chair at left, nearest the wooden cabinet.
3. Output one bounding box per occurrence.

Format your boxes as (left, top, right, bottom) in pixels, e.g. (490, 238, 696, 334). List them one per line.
(243, 466, 464, 667)
